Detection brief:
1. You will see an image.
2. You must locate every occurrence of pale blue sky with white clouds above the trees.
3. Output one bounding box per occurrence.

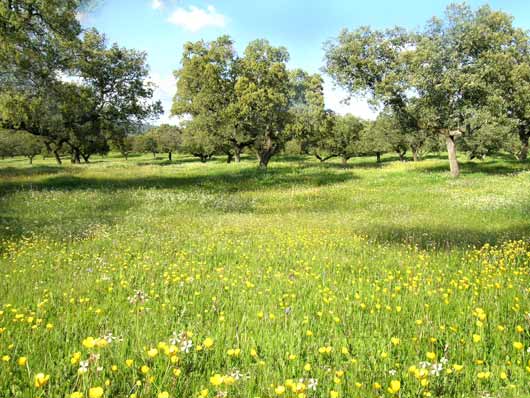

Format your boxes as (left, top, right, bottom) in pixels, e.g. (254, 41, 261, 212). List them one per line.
(80, 0, 530, 124)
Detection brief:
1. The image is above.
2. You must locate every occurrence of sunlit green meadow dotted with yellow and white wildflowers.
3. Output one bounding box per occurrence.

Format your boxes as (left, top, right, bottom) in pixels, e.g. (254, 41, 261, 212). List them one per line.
(0, 156, 530, 398)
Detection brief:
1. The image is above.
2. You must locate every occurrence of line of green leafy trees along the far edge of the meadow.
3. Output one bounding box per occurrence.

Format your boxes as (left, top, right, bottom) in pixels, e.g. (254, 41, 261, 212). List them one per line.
(0, 0, 530, 176)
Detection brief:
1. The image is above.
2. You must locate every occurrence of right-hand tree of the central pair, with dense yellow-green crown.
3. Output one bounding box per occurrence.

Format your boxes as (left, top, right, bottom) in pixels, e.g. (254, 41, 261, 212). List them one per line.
(229, 40, 291, 168)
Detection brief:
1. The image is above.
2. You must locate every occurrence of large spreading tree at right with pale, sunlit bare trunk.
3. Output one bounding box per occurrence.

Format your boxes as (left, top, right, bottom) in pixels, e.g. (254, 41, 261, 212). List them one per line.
(326, 5, 514, 177)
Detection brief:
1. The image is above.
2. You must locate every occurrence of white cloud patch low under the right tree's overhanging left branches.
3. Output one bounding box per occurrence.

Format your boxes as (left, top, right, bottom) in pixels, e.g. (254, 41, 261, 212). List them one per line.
(324, 79, 378, 120)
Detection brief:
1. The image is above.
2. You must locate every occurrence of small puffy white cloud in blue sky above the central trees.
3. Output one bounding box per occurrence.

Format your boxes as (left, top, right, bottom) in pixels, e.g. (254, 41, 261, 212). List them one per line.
(168, 6, 226, 32)
